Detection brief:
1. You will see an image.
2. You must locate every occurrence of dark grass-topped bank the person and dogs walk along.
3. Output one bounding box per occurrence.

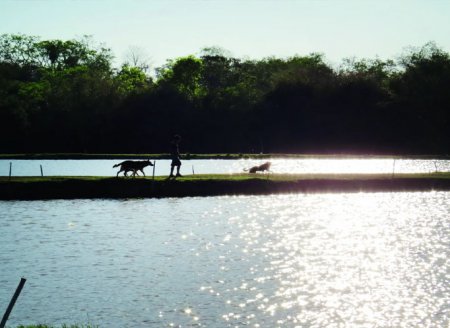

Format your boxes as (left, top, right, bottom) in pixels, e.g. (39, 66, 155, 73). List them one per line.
(0, 173, 450, 200)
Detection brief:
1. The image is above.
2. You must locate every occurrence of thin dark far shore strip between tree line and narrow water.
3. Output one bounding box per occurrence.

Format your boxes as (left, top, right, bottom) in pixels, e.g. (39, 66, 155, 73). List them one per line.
(0, 153, 450, 160)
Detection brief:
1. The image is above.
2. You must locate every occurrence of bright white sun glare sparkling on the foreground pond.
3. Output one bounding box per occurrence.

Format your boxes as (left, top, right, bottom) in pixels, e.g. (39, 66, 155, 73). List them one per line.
(205, 194, 448, 327)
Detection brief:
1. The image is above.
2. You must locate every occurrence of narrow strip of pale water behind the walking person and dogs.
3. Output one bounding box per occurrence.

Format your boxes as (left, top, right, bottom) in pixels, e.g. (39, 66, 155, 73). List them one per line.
(0, 158, 450, 176)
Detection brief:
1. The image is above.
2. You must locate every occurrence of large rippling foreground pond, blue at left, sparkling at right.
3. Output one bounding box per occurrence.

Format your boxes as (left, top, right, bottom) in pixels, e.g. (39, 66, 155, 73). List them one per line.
(0, 192, 450, 327)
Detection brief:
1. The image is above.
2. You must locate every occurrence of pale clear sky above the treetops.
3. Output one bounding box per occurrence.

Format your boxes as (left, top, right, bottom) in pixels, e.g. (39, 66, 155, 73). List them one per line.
(0, 0, 450, 67)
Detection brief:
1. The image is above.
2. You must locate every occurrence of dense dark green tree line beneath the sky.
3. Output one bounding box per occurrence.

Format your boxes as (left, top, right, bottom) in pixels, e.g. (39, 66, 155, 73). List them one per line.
(0, 34, 450, 154)
